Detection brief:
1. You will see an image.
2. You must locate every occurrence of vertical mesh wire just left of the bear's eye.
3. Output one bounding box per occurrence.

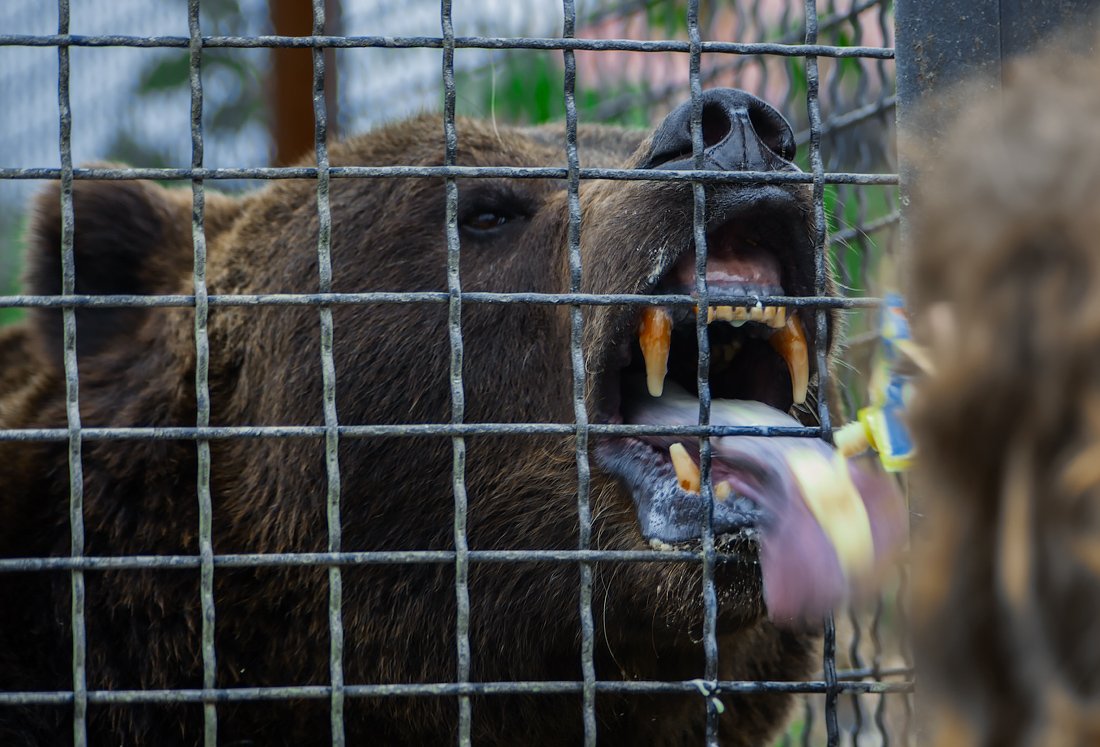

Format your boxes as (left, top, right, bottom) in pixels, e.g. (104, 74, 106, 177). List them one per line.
(440, 0, 471, 747)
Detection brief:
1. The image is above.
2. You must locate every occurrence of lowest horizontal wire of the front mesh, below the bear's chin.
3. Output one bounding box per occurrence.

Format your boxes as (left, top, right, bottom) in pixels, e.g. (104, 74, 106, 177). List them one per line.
(0, 680, 913, 706)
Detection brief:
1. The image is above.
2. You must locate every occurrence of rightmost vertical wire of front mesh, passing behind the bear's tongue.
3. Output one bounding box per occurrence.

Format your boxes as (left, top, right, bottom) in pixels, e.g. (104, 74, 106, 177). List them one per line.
(805, 0, 839, 747)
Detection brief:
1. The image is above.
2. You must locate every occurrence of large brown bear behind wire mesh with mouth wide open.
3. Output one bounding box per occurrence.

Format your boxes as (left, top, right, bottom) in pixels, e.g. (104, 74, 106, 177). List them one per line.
(0, 89, 897, 745)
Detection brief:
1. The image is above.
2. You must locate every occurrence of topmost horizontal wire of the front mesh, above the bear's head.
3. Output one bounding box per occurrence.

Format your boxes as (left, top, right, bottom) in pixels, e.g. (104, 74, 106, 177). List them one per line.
(0, 34, 894, 59)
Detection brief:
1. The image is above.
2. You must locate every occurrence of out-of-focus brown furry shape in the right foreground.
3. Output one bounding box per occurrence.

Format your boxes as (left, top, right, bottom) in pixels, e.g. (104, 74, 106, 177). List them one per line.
(911, 44, 1100, 746)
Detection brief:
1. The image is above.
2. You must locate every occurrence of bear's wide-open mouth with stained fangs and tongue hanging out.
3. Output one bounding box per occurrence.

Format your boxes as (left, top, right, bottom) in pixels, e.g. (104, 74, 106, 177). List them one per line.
(596, 199, 903, 619)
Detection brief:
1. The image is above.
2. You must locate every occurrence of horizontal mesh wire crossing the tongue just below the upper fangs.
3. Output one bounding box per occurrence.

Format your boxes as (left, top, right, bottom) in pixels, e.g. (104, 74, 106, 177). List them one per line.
(0, 422, 821, 442)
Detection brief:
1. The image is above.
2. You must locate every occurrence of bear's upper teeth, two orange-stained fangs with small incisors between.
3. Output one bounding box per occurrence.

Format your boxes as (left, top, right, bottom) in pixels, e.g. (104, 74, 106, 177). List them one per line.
(638, 303, 810, 405)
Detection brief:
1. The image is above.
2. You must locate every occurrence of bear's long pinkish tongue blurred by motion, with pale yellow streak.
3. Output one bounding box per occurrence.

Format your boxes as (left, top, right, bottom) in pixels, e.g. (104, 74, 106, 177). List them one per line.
(630, 393, 905, 624)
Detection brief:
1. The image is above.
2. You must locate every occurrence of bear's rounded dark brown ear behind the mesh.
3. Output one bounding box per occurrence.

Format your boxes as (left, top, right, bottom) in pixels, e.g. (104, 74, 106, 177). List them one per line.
(25, 180, 191, 366)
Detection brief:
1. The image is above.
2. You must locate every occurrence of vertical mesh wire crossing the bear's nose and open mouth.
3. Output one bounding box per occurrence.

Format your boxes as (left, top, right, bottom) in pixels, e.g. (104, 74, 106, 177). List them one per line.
(688, 0, 718, 747)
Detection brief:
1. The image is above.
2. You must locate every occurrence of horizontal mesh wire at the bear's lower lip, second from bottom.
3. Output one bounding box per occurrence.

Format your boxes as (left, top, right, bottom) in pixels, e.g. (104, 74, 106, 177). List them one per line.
(0, 550, 708, 573)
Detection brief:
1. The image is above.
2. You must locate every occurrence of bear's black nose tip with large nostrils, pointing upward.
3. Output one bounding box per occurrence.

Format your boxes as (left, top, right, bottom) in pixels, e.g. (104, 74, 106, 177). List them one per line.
(641, 88, 796, 172)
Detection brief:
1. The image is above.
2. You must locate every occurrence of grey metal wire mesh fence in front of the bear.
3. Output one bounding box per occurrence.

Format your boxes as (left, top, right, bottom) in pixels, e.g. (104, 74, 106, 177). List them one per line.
(0, 0, 912, 746)
